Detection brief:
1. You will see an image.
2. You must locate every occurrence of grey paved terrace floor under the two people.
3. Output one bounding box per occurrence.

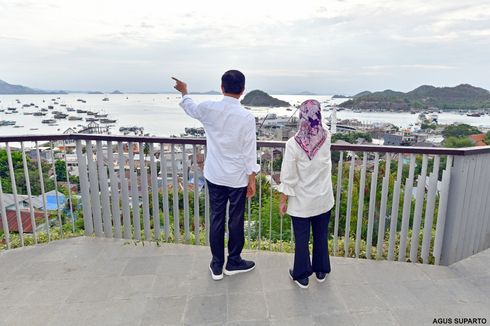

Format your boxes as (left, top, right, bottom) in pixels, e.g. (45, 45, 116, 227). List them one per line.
(0, 237, 490, 326)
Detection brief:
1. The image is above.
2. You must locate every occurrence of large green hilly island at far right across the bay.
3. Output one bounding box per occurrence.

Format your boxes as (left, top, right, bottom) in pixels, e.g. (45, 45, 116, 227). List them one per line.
(340, 84, 490, 111)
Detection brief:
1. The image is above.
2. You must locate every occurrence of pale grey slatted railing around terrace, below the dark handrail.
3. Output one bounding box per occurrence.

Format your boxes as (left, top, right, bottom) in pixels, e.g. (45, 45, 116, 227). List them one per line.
(0, 134, 490, 265)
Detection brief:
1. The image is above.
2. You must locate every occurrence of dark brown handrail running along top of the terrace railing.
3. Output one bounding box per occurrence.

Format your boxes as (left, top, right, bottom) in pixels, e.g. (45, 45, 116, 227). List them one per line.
(0, 133, 490, 156)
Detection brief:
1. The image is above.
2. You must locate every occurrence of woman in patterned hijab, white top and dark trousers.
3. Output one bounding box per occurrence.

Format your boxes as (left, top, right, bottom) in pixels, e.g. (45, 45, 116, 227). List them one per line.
(278, 100, 334, 288)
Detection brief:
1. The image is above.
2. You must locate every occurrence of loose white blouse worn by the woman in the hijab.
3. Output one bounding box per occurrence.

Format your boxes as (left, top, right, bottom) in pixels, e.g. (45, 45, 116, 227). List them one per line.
(278, 135, 334, 217)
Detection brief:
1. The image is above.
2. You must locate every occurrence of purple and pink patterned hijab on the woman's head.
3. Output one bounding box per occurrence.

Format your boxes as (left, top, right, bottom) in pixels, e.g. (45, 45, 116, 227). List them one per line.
(294, 100, 327, 160)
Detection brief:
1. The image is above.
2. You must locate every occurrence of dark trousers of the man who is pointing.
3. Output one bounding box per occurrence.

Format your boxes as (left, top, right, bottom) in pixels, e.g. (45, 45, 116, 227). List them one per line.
(206, 180, 247, 268)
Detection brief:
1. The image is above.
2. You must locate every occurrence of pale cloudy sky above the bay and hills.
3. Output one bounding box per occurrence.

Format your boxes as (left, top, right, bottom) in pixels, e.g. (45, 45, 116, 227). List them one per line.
(0, 0, 490, 95)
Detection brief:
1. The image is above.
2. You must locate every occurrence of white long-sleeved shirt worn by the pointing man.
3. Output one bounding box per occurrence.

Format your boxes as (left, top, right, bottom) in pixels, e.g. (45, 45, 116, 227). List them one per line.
(179, 95, 260, 188)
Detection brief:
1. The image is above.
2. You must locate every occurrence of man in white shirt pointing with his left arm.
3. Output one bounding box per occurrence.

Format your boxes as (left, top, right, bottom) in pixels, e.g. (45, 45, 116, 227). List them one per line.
(172, 70, 260, 281)
